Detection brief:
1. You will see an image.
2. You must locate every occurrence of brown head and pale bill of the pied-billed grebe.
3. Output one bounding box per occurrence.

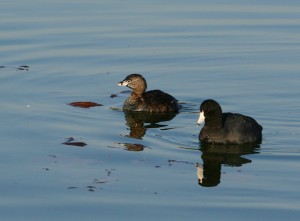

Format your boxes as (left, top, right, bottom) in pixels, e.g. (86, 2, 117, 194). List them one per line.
(118, 74, 147, 93)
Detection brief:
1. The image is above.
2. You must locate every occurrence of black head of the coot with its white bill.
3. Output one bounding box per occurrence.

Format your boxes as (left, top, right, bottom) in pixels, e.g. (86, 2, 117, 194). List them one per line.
(197, 99, 222, 125)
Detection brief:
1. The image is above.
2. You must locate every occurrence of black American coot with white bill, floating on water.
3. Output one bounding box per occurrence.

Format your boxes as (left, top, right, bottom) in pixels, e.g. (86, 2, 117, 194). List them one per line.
(198, 99, 263, 144)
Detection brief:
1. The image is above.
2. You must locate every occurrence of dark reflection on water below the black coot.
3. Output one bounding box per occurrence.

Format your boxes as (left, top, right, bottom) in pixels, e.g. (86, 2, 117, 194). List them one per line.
(197, 143, 260, 187)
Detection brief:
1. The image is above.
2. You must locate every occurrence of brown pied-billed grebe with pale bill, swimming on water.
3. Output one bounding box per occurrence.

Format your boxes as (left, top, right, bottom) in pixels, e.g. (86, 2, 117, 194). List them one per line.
(118, 74, 180, 113)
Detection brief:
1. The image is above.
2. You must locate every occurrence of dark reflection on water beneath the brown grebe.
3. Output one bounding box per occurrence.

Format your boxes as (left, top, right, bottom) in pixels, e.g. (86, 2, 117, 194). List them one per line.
(124, 110, 176, 139)
